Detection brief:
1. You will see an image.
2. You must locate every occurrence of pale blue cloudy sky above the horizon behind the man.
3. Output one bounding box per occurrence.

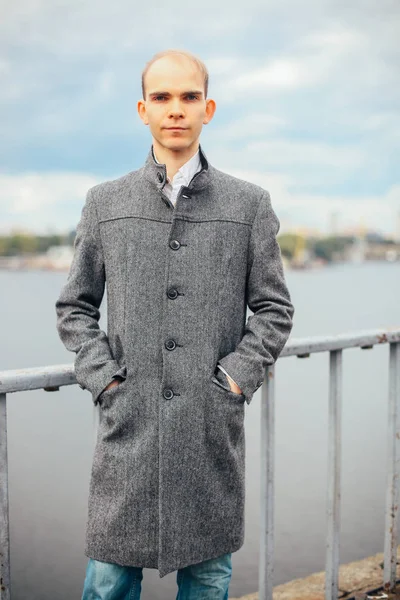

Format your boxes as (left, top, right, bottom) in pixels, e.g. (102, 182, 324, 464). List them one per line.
(0, 0, 400, 236)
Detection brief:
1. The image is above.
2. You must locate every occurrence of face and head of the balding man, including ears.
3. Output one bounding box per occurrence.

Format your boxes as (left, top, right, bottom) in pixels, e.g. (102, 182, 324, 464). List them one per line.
(138, 56, 215, 153)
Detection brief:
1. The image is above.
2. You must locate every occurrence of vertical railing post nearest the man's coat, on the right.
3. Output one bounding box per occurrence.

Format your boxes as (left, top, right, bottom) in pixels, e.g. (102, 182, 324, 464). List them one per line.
(258, 365, 275, 600)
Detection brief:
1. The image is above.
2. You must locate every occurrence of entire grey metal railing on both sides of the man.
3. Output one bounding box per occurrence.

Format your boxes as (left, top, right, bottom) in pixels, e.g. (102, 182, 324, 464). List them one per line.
(0, 328, 400, 600)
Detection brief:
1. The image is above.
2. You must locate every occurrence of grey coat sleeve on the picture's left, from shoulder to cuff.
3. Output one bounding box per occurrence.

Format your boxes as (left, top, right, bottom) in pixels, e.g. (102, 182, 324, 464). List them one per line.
(55, 189, 125, 404)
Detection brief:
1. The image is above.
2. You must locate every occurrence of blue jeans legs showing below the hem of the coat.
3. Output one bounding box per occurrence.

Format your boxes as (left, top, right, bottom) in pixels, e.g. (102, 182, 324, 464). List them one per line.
(81, 553, 232, 600)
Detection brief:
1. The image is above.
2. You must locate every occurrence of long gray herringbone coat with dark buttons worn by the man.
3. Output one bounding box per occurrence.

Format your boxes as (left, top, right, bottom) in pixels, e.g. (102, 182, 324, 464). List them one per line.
(56, 147, 294, 577)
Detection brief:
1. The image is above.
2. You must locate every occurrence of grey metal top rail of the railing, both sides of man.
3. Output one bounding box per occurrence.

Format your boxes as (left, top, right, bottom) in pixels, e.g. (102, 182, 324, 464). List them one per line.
(0, 327, 400, 394)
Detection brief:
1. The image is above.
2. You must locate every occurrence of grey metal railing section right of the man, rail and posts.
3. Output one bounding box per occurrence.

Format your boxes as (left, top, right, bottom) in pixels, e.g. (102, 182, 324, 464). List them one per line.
(258, 328, 400, 600)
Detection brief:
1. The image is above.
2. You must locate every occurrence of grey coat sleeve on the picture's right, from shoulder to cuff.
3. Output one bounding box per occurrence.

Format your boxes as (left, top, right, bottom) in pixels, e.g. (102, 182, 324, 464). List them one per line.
(218, 191, 294, 404)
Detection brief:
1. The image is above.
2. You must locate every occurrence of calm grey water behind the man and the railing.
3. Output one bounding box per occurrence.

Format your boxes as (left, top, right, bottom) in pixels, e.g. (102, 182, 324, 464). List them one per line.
(0, 263, 400, 600)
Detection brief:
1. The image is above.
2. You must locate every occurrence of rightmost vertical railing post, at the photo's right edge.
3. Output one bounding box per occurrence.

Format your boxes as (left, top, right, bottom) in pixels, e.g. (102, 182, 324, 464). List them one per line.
(383, 342, 400, 591)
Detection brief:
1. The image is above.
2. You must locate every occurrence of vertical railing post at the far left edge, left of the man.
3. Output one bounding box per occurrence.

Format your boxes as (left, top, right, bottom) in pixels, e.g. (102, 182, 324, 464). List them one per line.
(0, 393, 11, 600)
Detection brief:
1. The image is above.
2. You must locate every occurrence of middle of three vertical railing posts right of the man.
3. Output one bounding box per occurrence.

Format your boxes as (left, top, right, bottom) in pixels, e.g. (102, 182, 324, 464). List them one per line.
(325, 350, 342, 600)
